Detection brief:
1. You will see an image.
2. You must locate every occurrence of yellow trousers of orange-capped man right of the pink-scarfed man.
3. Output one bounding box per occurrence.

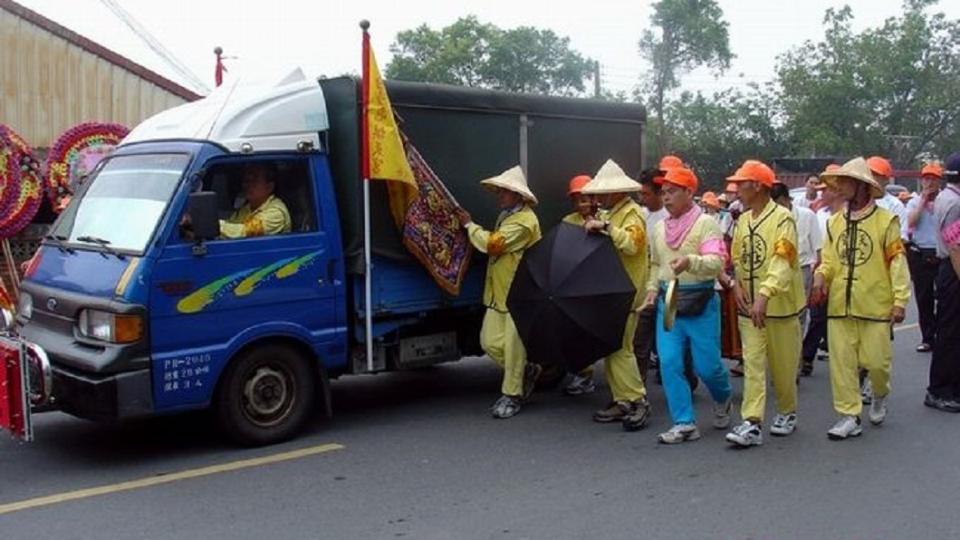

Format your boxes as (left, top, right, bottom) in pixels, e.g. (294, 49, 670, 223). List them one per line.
(738, 317, 804, 422)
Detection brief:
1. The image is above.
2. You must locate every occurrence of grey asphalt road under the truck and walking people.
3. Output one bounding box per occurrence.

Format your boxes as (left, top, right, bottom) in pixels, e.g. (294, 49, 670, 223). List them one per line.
(0, 314, 960, 540)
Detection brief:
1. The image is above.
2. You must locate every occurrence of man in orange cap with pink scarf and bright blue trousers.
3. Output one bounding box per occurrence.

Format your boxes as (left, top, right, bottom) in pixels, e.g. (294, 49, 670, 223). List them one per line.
(644, 168, 731, 444)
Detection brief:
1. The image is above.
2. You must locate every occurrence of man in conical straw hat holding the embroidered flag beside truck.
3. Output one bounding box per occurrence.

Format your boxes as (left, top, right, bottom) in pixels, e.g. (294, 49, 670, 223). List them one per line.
(457, 166, 540, 418)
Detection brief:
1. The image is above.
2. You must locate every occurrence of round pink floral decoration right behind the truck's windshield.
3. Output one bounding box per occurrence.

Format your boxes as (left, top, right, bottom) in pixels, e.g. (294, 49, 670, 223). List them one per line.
(46, 122, 130, 211)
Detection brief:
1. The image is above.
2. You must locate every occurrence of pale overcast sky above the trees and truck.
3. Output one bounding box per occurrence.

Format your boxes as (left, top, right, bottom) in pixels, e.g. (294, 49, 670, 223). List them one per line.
(16, 0, 960, 97)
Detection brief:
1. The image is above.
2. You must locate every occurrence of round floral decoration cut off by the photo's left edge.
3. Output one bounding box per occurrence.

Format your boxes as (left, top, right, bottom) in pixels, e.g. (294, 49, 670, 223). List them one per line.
(0, 124, 43, 238)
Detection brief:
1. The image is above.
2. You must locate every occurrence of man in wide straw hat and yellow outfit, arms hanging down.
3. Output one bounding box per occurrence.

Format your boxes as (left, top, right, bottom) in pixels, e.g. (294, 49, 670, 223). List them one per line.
(811, 158, 910, 440)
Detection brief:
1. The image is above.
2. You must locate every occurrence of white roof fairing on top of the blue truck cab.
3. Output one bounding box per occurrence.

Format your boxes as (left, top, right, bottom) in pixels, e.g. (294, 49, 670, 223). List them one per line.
(121, 69, 330, 152)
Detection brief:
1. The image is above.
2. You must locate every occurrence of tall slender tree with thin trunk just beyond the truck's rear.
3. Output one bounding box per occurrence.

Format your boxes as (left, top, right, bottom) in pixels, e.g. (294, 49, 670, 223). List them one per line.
(639, 0, 733, 155)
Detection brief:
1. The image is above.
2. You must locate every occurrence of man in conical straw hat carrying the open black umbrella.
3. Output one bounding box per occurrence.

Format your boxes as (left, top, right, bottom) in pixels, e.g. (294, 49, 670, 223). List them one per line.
(583, 160, 650, 431)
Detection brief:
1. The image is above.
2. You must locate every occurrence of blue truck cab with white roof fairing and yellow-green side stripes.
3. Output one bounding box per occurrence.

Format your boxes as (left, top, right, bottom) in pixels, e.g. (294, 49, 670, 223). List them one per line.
(18, 71, 348, 443)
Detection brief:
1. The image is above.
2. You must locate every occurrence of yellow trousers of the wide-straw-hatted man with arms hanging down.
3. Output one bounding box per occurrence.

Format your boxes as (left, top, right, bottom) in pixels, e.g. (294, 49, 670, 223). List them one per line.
(827, 317, 893, 416)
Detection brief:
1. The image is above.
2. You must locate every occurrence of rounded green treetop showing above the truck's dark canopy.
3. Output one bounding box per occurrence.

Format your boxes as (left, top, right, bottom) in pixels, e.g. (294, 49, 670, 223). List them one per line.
(386, 16, 593, 95)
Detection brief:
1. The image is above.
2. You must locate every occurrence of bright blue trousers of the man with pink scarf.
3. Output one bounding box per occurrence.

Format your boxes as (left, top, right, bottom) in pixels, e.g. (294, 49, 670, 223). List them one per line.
(657, 283, 732, 424)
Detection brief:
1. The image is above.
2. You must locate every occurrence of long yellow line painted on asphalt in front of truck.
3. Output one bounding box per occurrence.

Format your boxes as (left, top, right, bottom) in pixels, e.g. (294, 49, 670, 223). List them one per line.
(0, 444, 344, 515)
